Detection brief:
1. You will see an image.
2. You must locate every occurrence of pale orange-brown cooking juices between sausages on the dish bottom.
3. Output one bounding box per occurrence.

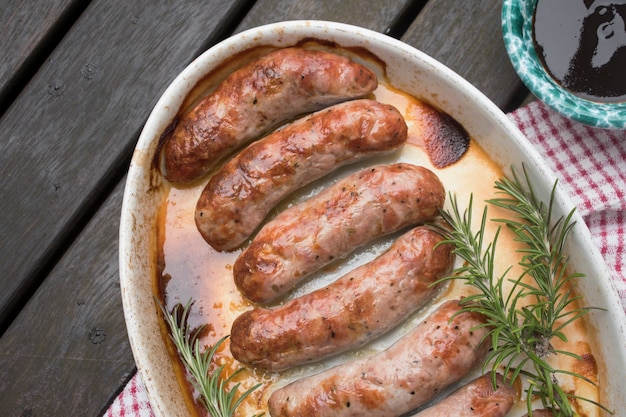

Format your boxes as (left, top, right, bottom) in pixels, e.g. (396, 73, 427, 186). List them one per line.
(157, 52, 598, 417)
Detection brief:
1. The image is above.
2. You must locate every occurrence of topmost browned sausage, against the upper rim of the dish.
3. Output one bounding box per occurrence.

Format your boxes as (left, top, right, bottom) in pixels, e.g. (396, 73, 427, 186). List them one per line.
(163, 48, 378, 183)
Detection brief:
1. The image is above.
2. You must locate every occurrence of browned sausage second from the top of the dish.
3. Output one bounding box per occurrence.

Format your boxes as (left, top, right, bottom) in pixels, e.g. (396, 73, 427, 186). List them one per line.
(195, 99, 407, 250)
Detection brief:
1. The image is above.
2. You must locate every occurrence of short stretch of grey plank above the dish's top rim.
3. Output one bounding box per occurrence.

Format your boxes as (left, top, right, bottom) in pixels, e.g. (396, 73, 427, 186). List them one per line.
(237, 0, 415, 33)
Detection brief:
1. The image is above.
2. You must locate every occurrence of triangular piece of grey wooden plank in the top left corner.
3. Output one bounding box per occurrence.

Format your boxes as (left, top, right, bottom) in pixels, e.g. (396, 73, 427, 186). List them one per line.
(0, 0, 86, 113)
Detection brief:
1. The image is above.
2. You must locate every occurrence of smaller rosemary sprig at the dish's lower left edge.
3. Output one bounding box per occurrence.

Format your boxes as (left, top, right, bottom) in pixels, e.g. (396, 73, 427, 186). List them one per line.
(159, 300, 264, 417)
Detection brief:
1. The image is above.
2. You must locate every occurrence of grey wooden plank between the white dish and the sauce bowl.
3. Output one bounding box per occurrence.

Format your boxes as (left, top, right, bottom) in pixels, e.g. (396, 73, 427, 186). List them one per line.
(402, 0, 524, 111)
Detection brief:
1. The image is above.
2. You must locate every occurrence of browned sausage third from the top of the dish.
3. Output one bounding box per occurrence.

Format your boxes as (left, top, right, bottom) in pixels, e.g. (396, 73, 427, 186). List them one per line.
(233, 163, 445, 303)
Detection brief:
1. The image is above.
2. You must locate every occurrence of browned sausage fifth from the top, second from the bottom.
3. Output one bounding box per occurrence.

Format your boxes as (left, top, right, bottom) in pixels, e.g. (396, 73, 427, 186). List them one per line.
(269, 300, 489, 417)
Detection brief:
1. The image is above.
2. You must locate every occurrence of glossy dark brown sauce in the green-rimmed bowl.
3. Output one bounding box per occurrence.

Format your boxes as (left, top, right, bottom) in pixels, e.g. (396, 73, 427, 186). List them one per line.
(533, 0, 626, 103)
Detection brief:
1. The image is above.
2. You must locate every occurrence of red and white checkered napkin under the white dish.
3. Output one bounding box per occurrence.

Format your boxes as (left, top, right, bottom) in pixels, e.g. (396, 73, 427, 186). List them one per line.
(105, 101, 626, 417)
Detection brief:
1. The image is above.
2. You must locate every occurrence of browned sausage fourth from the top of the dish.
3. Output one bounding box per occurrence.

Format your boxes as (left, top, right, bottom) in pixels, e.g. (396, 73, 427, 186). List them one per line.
(230, 226, 453, 371)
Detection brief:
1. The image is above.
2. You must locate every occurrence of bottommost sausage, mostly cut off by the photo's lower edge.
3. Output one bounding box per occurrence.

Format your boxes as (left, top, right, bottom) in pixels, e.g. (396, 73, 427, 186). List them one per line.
(412, 374, 517, 417)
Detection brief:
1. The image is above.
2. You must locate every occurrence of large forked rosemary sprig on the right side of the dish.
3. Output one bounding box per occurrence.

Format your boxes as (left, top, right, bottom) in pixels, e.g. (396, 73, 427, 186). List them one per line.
(438, 164, 608, 417)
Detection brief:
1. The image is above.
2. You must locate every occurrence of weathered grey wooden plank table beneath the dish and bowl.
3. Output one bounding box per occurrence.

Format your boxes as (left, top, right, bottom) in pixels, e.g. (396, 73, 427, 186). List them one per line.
(0, 0, 528, 417)
